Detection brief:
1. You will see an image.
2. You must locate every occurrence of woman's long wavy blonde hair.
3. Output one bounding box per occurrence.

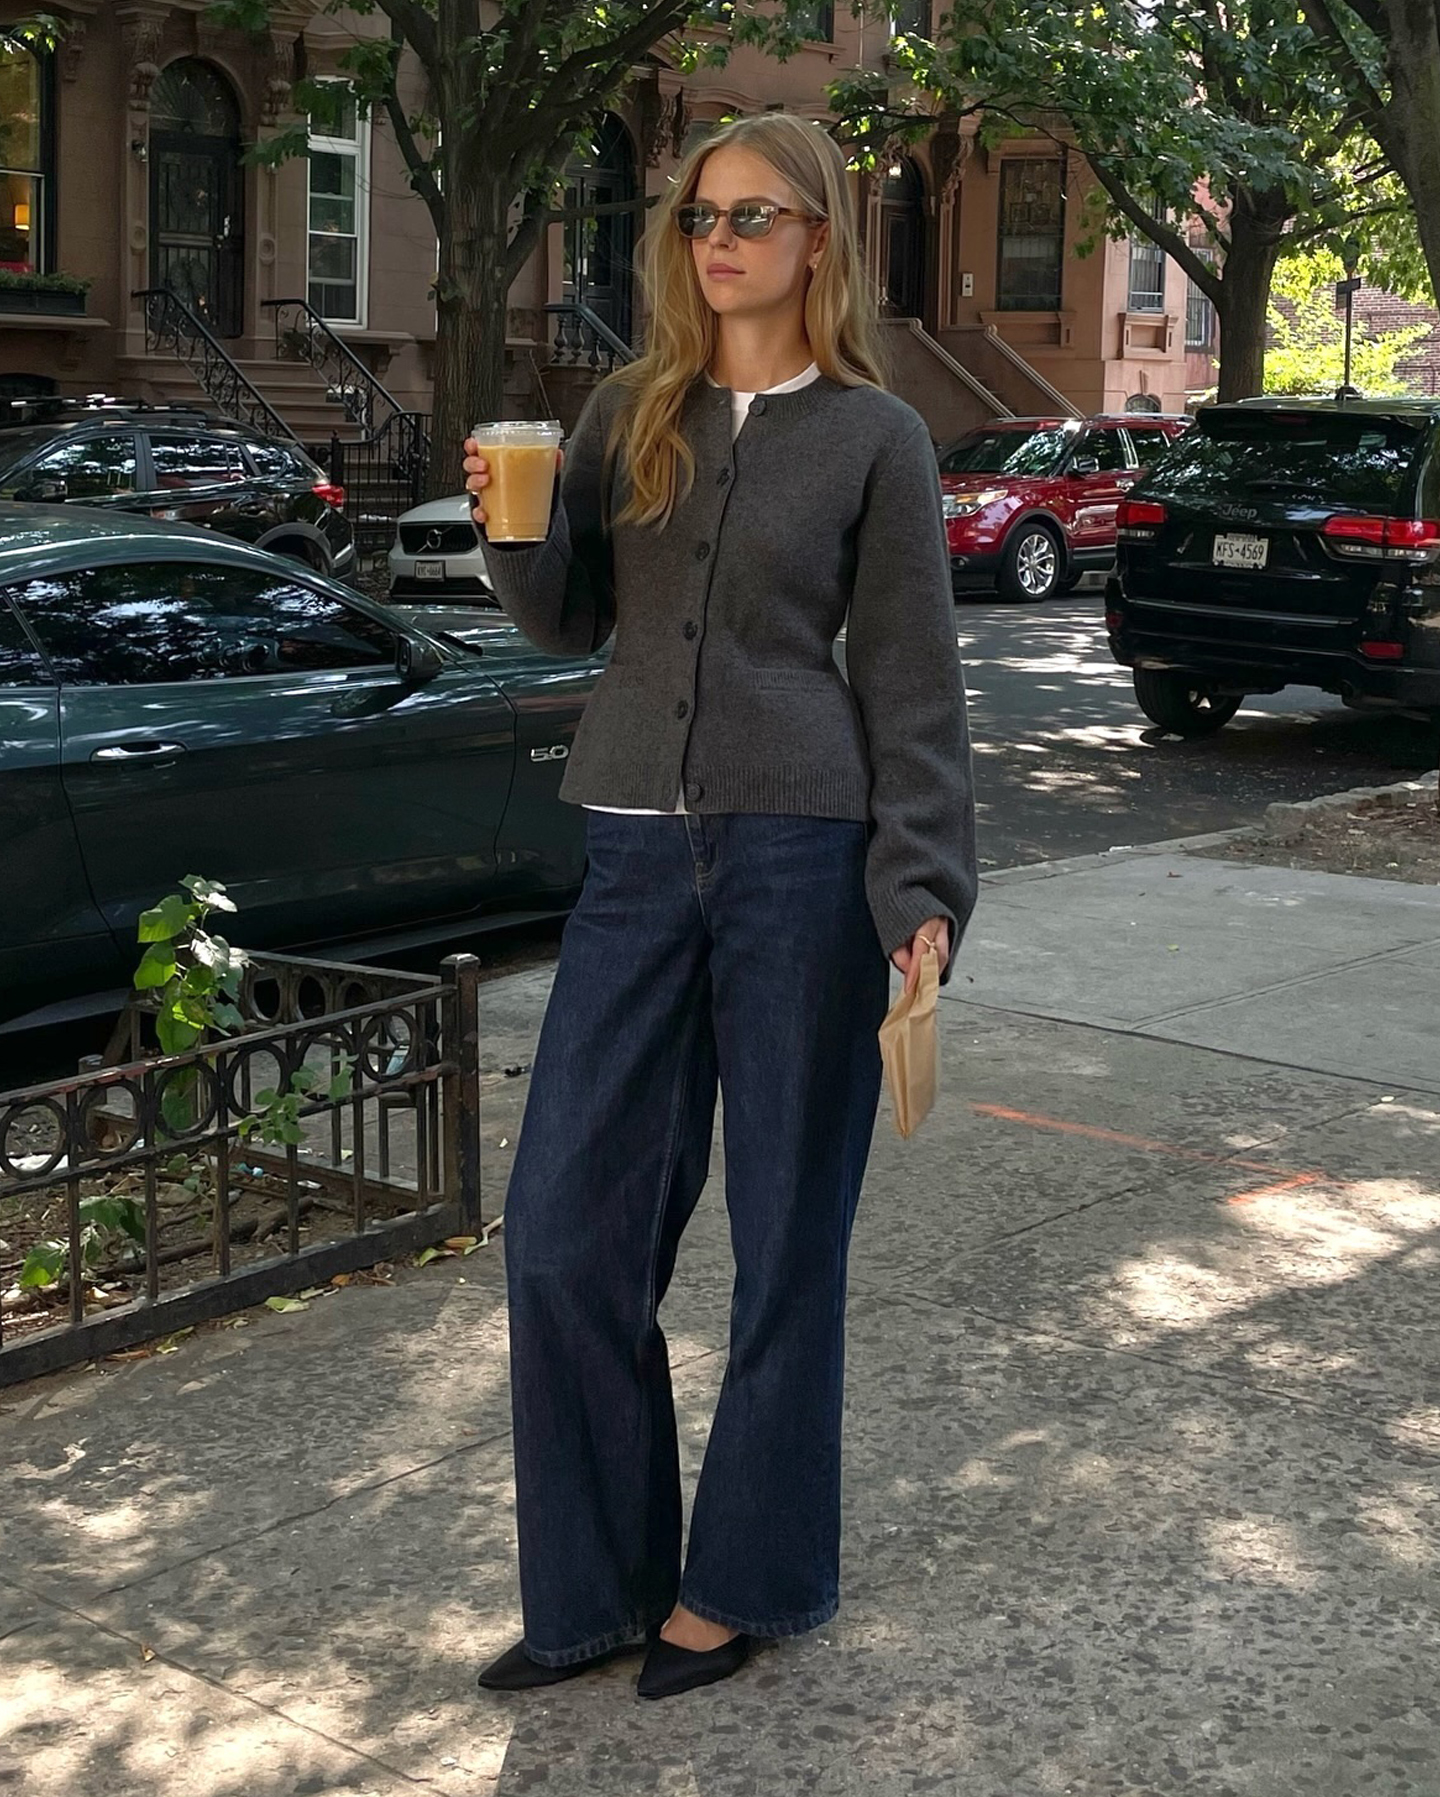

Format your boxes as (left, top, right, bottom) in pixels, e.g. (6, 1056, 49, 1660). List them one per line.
(608, 113, 884, 525)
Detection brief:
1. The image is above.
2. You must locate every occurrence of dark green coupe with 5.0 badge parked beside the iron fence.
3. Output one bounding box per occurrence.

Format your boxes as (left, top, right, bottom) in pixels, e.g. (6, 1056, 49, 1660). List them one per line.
(0, 503, 602, 1022)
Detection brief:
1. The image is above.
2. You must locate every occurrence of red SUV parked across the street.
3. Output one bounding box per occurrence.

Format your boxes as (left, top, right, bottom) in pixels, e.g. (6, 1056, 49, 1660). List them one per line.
(940, 412, 1194, 600)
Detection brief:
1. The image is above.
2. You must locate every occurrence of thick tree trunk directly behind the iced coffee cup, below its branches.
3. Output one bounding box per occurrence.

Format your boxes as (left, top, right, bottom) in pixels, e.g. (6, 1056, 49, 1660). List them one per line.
(426, 171, 509, 500)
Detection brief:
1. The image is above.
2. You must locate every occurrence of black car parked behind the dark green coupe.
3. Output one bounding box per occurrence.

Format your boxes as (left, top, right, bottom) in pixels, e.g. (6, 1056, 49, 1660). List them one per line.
(0, 399, 354, 579)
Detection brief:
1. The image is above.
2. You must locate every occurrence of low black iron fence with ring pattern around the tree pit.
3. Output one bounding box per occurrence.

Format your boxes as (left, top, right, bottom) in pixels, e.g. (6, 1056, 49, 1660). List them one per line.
(0, 954, 482, 1385)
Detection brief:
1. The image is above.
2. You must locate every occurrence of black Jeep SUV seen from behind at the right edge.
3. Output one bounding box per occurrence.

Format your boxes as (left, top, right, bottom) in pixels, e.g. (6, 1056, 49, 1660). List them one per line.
(1106, 399, 1440, 737)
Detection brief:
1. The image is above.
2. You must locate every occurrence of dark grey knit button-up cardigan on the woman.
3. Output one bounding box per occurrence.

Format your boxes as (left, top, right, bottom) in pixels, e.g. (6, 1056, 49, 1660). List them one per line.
(487, 376, 976, 954)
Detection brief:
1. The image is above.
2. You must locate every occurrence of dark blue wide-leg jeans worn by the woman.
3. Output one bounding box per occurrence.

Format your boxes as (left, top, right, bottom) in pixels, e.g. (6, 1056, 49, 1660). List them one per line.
(505, 812, 888, 1666)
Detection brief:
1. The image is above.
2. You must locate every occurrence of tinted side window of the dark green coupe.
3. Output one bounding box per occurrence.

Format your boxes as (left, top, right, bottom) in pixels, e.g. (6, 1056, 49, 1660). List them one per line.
(11, 562, 396, 686)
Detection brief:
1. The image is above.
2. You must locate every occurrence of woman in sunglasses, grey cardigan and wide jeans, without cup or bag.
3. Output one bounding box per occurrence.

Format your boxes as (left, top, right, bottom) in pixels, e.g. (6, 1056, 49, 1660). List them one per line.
(466, 113, 974, 1696)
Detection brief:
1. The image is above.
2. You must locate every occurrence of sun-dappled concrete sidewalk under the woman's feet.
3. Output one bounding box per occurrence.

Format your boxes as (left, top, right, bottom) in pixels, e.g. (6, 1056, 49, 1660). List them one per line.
(0, 833, 1440, 1797)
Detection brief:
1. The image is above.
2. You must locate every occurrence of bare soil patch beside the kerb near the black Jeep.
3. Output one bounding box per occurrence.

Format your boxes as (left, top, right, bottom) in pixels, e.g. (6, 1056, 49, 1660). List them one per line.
(1204, 791, 1440, 886)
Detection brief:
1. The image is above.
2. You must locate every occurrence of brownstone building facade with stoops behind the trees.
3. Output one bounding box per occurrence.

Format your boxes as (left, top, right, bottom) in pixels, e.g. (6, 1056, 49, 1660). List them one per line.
(0, 0, 1212, 463)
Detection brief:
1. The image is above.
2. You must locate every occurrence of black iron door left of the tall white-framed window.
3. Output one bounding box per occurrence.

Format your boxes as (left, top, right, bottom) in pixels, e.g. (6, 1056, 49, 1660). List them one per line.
(149, 131, 244, 338)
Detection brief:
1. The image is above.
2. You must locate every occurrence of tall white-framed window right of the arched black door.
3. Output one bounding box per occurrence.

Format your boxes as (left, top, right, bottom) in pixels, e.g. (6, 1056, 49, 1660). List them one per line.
(309, 81, 370, 325)
